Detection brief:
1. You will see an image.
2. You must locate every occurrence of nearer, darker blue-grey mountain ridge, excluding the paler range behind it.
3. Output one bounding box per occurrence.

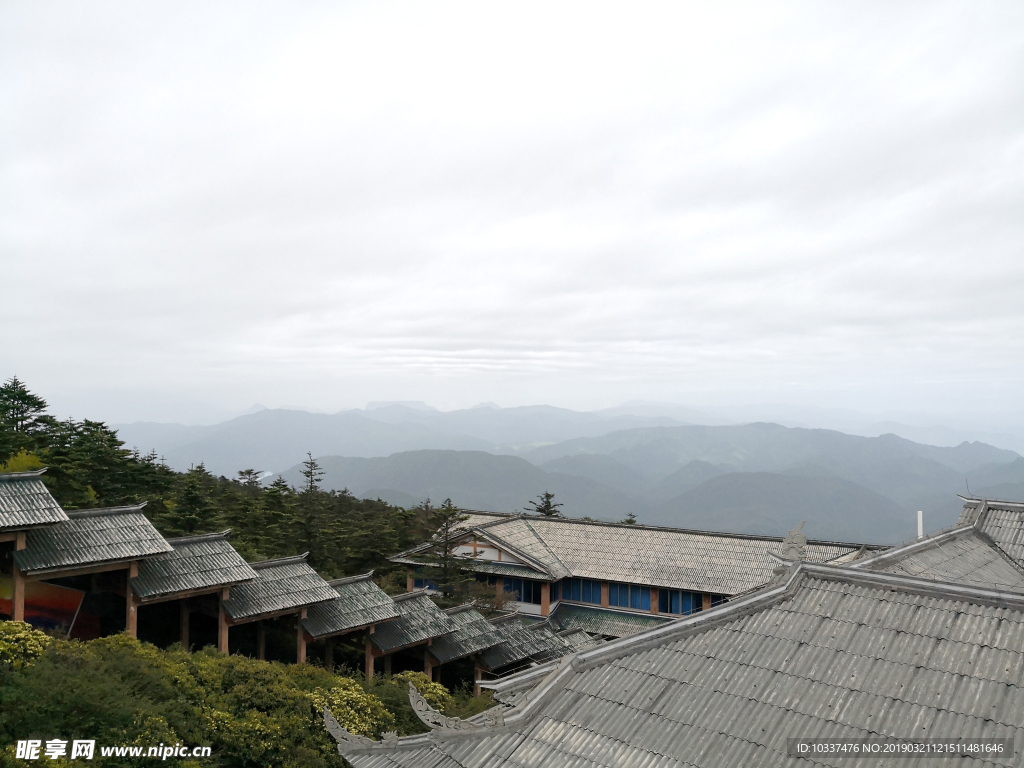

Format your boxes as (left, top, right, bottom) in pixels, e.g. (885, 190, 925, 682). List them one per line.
(272, 424, 1024, 544)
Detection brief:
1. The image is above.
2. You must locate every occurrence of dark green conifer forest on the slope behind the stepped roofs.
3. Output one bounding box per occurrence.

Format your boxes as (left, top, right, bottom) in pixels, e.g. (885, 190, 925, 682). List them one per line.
(0, 378, 436, 584)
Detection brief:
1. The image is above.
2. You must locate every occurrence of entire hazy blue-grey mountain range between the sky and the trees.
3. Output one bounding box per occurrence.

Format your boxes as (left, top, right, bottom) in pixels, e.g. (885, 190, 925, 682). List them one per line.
(112, 403, 1024, 544)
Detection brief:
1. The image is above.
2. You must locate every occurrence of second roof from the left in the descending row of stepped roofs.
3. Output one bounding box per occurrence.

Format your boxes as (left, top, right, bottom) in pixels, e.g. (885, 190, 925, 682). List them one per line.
(14, 504, 171, 572)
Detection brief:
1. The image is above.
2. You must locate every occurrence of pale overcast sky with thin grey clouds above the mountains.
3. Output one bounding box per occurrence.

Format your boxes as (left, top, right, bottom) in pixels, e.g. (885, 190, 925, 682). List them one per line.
(0, 0, 1024, 421)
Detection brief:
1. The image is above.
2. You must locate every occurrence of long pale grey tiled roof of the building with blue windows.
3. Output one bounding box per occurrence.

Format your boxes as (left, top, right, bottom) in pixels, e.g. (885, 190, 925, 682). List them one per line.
(395, 512, 882, 595)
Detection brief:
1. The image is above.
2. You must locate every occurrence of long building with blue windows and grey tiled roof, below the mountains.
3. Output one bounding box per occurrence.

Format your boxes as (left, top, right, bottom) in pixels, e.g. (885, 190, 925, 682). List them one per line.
(391, 512, 883, 638)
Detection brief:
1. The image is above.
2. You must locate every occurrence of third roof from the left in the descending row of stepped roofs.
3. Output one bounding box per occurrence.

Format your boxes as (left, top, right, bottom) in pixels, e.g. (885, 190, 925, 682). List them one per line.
(131, 530, 256, 600)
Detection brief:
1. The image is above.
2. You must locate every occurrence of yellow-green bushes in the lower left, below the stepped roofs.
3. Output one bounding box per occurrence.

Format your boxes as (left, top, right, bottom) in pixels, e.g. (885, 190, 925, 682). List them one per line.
(0, 622, 489, 768)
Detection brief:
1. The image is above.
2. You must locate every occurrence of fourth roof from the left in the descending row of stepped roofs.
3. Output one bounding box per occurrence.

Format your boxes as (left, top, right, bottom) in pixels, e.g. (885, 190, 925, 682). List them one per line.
(224, 552, 337, 622)
